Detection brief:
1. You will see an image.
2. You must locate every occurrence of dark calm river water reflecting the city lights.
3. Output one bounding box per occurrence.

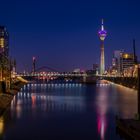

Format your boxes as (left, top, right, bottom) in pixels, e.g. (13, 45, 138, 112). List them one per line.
(0, 82, 137, 140)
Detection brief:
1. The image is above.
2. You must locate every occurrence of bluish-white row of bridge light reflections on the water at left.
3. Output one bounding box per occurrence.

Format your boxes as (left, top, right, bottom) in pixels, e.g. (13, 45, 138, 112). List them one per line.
(11, 84, 85, 118)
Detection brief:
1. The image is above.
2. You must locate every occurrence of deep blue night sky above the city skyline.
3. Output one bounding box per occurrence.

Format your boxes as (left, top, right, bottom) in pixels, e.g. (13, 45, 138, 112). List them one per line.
(0, 0, 140, 71)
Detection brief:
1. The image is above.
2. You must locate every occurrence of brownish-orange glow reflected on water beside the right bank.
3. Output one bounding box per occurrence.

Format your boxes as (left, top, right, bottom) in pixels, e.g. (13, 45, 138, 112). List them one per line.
(111, 83, 138, 119)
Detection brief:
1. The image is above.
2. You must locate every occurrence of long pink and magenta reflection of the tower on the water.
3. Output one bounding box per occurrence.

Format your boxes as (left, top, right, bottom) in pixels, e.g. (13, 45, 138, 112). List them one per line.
(96, 87, 108, 140)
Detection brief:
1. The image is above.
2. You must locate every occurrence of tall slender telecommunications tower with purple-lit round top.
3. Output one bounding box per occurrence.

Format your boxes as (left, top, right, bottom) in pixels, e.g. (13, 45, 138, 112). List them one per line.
(98, 19, 107, 75)
